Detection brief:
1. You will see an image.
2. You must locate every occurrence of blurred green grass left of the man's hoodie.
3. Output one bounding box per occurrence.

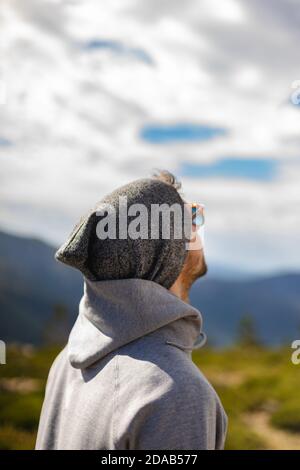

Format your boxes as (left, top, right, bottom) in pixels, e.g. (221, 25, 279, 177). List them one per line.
(0, 346, 59, 450)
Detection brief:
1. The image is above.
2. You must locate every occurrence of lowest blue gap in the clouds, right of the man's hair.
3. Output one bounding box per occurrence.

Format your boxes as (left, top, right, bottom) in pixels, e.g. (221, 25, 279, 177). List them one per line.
(179, 158, 277, 181)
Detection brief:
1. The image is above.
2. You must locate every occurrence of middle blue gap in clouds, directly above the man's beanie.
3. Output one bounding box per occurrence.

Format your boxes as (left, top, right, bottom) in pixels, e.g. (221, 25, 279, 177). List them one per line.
(140, 123, 226, 144)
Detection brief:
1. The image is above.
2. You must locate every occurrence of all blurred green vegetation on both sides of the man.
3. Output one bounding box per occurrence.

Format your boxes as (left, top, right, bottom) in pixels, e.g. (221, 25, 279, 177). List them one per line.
(0, 344, 300, 449)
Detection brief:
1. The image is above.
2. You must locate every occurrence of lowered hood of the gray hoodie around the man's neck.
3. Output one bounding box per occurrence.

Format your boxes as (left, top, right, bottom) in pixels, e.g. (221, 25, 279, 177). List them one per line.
(68, 279, 206, 369)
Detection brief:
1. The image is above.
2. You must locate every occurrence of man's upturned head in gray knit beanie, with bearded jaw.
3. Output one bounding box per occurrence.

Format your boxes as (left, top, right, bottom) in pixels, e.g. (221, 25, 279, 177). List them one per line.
(56, 172, 205, 302)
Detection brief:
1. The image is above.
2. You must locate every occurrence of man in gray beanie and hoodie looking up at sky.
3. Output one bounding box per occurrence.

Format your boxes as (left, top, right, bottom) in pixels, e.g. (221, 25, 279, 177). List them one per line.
(36, 172, 227, 450)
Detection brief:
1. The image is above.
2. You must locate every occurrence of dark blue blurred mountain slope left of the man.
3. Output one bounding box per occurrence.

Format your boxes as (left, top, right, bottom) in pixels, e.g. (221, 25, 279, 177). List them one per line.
(0, 232, 82, 343)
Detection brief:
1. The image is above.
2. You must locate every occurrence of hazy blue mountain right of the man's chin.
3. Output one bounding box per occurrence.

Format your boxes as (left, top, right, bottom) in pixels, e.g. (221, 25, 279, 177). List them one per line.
(190, 274, 300, 346)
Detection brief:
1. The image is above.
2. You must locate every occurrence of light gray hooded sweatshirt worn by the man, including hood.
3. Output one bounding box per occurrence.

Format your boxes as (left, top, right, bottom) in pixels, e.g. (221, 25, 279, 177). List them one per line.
(36, 279, 227, 450)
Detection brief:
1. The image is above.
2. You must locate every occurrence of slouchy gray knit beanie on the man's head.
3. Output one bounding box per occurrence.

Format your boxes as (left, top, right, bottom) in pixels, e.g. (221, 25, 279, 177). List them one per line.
(55, 178, 187, 289)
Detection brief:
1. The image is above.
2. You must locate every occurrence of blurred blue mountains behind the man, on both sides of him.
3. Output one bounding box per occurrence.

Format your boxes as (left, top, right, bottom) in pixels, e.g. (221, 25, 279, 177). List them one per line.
(0, 232, 300, 346)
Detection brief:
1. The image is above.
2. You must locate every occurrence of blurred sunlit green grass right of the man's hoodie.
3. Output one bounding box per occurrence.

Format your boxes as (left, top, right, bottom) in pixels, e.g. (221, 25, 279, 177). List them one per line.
(193, 347, 300, 449)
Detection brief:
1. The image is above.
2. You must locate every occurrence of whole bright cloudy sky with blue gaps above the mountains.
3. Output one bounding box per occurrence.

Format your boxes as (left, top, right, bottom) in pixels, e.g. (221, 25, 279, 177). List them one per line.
(0, 0, 300, 273)
